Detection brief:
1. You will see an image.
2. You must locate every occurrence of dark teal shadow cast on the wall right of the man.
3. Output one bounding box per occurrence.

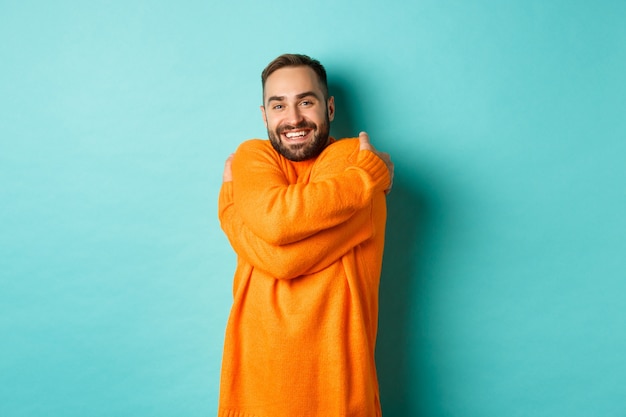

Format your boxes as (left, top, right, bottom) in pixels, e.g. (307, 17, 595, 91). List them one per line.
(329, 81, 429, 417)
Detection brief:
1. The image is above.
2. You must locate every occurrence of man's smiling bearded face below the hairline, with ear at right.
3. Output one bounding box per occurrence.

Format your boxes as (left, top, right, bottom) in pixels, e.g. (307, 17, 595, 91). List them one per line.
(261, 66, 335, 161)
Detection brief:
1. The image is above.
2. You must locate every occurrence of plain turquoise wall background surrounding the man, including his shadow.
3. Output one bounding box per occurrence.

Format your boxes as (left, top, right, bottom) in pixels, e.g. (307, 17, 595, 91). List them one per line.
(0, 0, 626, 417)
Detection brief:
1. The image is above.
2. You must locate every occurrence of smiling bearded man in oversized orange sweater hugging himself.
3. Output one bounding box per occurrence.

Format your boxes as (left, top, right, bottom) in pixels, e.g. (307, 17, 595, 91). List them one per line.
(219, 54, 393, 417)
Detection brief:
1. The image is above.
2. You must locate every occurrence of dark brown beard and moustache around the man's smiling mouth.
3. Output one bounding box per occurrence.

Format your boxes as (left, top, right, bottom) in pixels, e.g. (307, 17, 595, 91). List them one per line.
(267, 115, 330, 162)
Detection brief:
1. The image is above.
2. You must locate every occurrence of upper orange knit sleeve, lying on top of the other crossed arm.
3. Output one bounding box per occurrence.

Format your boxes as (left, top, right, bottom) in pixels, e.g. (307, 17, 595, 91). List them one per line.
(232, 139, 390, 245)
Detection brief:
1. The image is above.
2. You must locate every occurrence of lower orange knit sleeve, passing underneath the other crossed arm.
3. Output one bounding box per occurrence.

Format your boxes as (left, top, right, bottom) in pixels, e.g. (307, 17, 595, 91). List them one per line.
(219, 182, 373, 279)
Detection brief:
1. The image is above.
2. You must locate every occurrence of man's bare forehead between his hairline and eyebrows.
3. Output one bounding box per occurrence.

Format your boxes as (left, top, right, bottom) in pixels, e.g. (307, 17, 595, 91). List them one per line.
(263, 66, 322, 101)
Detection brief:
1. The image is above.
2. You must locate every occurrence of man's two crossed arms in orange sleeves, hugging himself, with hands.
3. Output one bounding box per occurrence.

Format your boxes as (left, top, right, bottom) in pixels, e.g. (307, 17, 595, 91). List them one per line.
(219, 134, 393, 279)
